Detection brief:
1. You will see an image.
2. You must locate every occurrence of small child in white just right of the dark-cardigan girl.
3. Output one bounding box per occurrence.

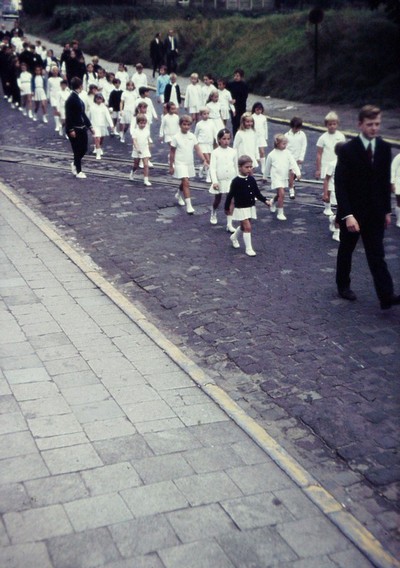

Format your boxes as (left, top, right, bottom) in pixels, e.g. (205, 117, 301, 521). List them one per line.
(264, 134, 301, 221)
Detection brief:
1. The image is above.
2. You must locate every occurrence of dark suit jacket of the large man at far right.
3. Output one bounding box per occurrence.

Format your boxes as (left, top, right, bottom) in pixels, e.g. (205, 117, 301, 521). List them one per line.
(335, 136, 392, 223)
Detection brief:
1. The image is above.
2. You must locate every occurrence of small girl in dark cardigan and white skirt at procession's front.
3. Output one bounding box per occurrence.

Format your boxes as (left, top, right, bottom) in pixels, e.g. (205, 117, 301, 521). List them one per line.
(225, 156, 270, 256)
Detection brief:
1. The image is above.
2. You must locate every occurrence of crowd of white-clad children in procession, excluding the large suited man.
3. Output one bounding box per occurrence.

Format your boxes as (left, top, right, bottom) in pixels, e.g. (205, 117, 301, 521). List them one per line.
(0, 27, 400, 256)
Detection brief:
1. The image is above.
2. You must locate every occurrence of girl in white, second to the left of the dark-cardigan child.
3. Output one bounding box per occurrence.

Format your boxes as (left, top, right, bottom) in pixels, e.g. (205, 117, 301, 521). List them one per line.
(169, 114, 207, 215)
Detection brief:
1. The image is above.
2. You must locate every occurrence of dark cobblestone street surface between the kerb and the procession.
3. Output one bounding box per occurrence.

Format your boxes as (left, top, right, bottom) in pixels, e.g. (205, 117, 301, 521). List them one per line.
(0, 28, 400, 554)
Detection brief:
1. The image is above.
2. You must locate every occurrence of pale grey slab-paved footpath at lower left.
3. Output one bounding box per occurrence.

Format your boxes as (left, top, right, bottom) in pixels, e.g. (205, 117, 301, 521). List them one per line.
(0, 187, 388, 568)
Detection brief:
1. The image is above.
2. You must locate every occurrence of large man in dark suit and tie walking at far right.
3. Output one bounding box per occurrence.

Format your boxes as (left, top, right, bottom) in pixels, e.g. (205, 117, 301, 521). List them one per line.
(335, 105, 400, 310)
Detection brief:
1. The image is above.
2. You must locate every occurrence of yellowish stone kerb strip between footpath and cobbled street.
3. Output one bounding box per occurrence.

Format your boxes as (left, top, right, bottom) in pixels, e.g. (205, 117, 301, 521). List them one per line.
(0, 183, 400, 568)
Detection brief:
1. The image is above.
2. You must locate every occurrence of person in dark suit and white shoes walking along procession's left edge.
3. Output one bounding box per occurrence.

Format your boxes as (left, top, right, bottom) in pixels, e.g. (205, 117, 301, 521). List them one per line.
(65, 77, 94, 179)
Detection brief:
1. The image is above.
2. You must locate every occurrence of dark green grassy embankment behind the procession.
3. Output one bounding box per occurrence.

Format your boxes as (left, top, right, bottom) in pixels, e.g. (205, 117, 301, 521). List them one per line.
(26, 7, 400, 108)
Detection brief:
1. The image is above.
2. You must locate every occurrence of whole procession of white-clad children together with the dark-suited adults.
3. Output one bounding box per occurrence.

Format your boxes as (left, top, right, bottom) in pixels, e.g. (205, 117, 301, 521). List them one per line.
(1, 22, 400, 309)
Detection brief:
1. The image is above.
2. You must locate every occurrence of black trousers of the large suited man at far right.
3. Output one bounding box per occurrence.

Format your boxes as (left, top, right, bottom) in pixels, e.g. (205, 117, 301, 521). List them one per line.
(336, 218, 393, 301)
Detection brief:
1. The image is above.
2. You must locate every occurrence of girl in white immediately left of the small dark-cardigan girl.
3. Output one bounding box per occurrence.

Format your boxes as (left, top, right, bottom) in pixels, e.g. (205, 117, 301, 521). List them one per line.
(209, 128, 238, 233)
